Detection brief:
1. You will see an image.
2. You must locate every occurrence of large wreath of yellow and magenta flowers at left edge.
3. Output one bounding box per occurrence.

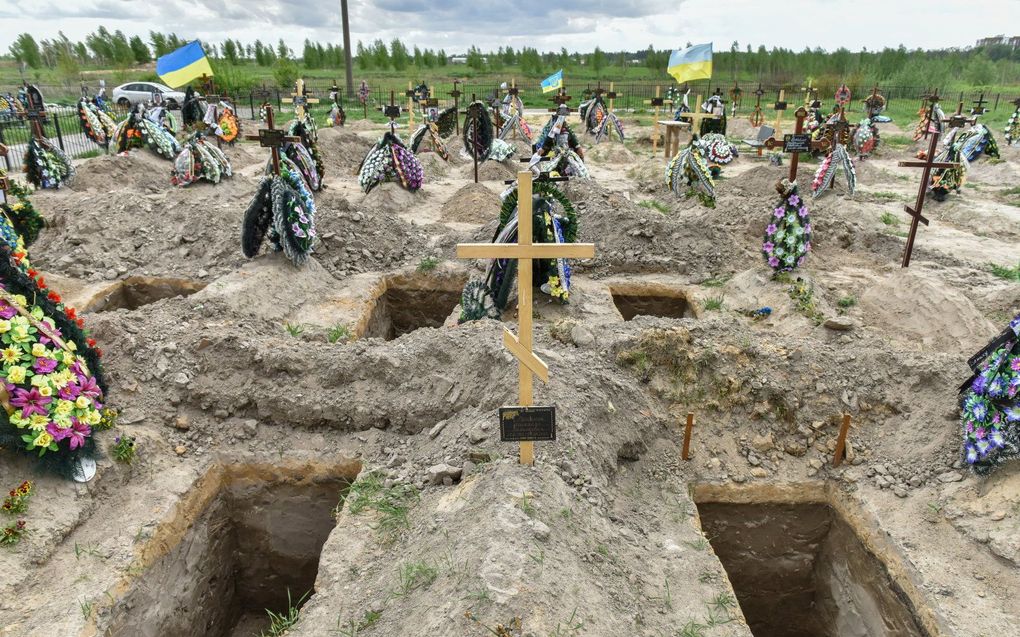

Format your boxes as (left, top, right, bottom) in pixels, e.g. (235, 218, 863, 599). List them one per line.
(0, 243, 112, 476)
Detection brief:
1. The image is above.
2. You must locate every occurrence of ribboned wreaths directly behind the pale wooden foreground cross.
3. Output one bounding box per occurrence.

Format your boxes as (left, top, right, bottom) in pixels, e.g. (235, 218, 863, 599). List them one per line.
(458, 181, 578, 323)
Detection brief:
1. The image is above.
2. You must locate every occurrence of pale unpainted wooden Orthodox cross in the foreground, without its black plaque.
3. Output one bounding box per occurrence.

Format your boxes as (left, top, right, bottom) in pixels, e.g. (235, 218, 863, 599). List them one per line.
(457, 170, 595, 465)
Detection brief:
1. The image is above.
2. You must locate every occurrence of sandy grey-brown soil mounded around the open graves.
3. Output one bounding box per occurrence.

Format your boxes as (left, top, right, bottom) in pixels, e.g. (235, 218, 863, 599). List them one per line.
(0, 111, 1020, 637)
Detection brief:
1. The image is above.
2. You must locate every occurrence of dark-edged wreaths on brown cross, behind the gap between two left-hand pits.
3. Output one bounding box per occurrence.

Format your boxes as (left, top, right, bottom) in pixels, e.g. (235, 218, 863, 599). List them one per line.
(241, 156, 315, 266)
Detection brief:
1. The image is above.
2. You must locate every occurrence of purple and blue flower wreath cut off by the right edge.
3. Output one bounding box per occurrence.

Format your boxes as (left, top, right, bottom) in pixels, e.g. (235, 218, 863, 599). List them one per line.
(960, 315, 1020, 474)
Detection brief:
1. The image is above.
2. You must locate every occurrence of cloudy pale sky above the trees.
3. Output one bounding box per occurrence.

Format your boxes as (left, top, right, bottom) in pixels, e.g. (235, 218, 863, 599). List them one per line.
(0, 0, 1020, 53)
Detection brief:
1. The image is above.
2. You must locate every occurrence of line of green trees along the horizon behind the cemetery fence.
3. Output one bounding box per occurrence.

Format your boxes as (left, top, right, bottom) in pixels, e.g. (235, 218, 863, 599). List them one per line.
(9, 26, 1020, 87)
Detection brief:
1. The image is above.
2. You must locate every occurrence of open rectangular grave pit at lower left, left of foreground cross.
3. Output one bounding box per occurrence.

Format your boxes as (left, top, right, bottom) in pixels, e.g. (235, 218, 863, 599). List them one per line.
(103, 461, 361, 637)
